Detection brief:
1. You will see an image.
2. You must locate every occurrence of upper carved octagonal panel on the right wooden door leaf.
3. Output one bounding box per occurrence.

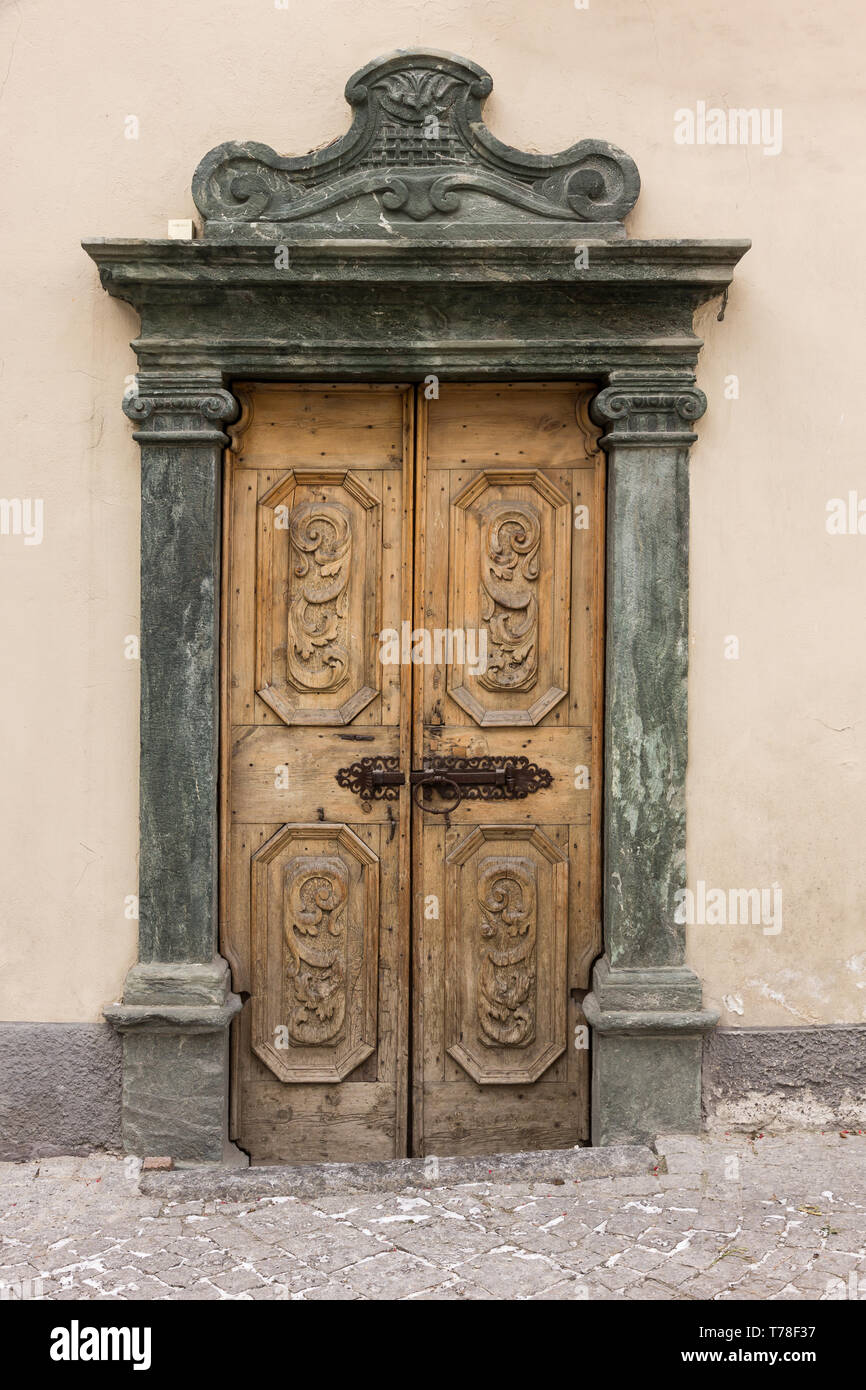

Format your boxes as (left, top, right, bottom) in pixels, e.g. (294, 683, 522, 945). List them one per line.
(448, 468, 571, 726)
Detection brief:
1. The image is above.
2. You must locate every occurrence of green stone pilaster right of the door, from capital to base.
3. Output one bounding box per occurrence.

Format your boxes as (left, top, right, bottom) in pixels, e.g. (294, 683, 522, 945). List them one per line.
(584, 371, 717, 1144)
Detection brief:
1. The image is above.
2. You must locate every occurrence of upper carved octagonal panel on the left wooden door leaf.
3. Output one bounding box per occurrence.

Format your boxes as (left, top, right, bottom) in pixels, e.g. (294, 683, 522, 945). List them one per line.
(256, 470, 382, 724)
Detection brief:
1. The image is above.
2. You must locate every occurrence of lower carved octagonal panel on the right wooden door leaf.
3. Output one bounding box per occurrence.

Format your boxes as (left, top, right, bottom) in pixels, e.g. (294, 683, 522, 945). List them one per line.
(445, 826, 569, 1086)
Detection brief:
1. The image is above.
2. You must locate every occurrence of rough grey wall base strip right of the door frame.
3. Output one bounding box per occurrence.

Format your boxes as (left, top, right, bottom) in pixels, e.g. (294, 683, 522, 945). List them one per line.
(703, 1024, 866, 1130)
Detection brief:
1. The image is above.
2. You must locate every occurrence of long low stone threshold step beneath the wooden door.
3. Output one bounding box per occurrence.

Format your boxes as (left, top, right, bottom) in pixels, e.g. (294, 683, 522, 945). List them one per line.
(139, 1144, 659, 1201)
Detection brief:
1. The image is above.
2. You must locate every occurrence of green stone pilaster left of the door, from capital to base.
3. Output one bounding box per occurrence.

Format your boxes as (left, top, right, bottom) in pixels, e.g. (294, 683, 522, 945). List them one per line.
(106, 377, 239, 1162)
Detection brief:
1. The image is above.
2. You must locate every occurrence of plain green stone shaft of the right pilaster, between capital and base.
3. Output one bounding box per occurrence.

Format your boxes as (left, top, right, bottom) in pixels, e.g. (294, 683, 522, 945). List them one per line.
(605, 436, 688, 967)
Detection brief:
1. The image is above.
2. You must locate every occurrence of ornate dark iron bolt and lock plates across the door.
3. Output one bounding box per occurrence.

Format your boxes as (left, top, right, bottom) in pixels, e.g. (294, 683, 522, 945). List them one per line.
(336, 755, 553, 815)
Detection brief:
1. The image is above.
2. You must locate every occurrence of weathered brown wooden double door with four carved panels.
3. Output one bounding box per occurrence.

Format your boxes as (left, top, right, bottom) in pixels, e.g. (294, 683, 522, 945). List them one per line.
(221, 382, 605, 1163)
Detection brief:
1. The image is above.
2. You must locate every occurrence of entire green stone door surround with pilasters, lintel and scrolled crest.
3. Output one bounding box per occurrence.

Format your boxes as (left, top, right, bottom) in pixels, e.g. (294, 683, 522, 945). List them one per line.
(83, 53, 748, 1163)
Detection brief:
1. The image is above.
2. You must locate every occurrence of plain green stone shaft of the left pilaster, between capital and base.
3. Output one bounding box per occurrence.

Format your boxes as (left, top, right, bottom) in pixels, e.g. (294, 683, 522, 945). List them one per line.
(139, 425, 229, 962)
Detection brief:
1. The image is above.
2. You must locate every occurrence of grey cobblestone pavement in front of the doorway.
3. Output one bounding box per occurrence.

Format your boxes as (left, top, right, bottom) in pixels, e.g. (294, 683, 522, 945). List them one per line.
(0, 1133, 866, 1300)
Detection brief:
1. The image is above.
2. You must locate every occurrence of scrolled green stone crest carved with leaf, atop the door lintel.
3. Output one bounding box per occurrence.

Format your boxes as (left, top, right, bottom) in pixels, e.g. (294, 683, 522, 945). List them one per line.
(193, 50, 639, 238)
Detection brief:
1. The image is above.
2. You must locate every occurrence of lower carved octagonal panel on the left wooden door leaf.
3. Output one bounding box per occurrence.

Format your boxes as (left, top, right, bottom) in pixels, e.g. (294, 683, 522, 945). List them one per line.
(252, 823, 379, 1081)
